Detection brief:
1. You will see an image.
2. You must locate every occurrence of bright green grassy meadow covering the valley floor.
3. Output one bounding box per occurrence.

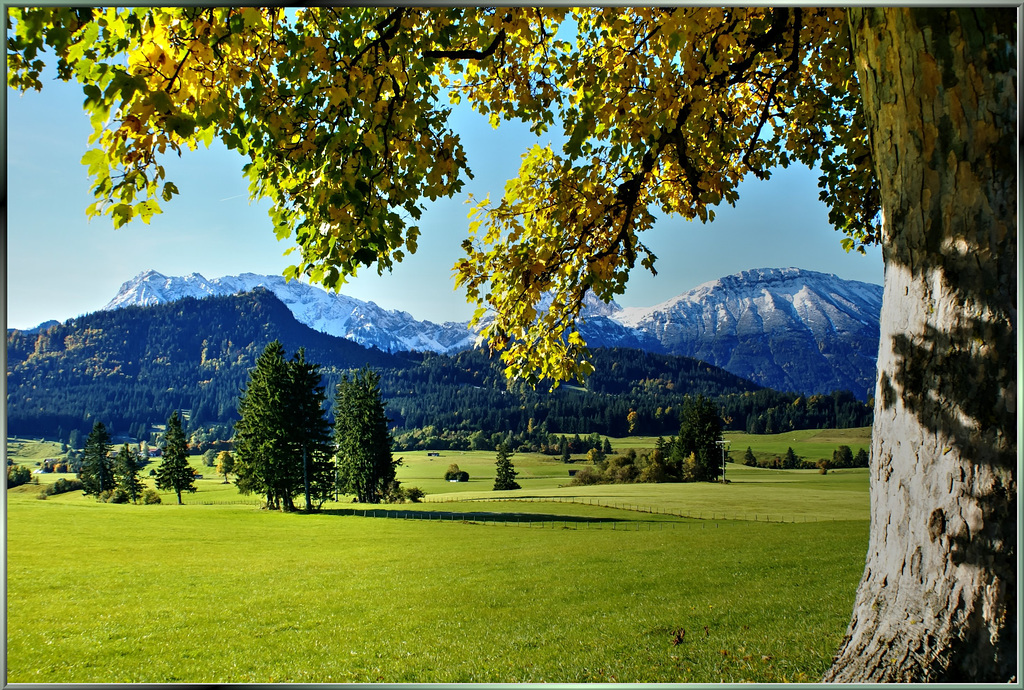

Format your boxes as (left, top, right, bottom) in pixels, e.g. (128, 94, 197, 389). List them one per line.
(7, 432, 868, 683)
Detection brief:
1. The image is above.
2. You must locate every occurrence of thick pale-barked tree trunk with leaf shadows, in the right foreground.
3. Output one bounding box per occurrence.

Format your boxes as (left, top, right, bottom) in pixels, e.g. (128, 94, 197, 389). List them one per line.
(824, 7, 1017, 682)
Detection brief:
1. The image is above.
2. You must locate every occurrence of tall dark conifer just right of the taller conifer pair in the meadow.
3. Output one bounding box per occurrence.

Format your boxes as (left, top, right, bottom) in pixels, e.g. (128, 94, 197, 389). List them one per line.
(334, 368, 401, 503)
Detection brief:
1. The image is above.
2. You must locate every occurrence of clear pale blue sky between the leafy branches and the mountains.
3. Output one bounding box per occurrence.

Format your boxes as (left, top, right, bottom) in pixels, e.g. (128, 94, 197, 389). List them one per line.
(6, 68, 883, 329)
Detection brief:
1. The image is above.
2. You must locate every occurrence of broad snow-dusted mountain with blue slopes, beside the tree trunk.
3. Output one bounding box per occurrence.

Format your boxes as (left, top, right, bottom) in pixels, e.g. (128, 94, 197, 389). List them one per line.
(612, 268, 882, 398)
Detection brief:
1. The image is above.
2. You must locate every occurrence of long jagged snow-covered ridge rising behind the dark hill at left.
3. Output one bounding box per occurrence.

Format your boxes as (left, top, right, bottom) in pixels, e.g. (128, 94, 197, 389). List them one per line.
(103, 270, 477, 353)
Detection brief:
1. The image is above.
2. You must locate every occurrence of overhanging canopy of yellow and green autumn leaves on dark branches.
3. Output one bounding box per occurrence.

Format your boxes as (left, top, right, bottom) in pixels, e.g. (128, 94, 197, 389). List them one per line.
(8, 7, 879, 382)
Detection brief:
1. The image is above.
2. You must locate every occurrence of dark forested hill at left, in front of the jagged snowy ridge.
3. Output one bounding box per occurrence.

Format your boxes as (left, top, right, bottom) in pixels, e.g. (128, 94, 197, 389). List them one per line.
(7, 290, 407, 437)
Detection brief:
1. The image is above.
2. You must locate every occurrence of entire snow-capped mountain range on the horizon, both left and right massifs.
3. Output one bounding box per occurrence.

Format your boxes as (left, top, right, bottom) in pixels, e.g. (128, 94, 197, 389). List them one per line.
(96, 268, 882, 400)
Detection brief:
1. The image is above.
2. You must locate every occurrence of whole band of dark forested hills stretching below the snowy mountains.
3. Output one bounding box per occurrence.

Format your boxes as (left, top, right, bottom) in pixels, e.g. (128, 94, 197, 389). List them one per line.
(7, 290, 870, 447)
